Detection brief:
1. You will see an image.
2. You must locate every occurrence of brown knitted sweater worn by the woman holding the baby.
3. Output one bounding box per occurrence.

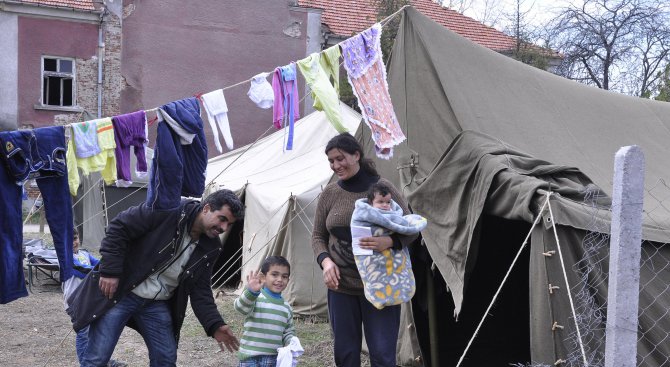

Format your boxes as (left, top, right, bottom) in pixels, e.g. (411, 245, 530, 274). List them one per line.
(312, 178, 417, 296)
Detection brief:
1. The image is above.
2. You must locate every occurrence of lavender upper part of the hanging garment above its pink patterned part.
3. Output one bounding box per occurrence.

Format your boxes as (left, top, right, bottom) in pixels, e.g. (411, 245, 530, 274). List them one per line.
(341, 23, 382, 78)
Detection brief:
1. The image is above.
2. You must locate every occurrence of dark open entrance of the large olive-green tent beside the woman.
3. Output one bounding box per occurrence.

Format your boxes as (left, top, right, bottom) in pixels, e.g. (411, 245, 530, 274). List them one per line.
(412, 215, 531, 367)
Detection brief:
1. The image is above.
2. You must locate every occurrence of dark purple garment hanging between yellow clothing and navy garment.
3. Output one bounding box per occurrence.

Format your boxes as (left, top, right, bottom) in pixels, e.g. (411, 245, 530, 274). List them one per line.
(112, 111, 148, 183)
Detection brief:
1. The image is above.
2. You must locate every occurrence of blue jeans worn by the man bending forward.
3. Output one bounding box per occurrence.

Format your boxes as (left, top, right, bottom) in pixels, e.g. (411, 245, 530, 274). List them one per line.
(81, 293, 177, 367)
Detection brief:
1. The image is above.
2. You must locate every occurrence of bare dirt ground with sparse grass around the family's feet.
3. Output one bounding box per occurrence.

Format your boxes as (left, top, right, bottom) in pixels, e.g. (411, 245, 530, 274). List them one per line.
(0, 268, 346, 367)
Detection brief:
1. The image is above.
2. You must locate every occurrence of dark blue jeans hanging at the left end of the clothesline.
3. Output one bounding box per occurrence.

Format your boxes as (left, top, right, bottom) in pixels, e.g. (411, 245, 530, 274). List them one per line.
(0, 126, 74, 303)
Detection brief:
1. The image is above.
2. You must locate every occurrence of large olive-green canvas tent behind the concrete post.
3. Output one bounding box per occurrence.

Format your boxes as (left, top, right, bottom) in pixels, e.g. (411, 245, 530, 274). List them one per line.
(364, 8, 670, 366)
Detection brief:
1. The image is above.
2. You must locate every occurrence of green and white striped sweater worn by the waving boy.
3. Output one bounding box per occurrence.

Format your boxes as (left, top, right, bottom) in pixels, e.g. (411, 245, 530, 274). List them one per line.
(235, 288, 295, 361)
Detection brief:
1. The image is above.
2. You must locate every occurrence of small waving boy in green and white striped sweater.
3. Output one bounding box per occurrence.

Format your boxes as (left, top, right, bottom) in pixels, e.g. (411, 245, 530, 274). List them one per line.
(235, 256, 295, 367)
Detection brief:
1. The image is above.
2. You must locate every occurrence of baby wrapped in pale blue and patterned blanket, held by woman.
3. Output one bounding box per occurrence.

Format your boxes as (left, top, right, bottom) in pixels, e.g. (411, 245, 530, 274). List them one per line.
(351, 182, 428, 309)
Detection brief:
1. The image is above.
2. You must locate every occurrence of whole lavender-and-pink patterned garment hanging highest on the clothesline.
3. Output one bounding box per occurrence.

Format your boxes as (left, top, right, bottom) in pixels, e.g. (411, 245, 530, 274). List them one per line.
(341, 23, 405, 159)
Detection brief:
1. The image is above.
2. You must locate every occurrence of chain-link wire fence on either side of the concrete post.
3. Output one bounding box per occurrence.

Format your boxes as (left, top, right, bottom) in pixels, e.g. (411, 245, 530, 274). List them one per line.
(562, 176, 670, 367)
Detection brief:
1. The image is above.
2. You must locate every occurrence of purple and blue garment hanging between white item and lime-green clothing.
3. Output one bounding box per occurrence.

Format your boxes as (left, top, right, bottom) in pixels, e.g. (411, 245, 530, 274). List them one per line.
(272, 63, 300, 150)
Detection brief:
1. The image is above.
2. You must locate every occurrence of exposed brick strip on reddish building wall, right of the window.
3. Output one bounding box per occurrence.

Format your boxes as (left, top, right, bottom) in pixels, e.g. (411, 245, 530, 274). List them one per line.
(102, 12, 123, 117)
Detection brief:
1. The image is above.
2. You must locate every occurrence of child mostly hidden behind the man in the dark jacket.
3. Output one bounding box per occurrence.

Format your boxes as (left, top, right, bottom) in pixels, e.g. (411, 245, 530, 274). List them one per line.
(63, 228, 127, 367)
